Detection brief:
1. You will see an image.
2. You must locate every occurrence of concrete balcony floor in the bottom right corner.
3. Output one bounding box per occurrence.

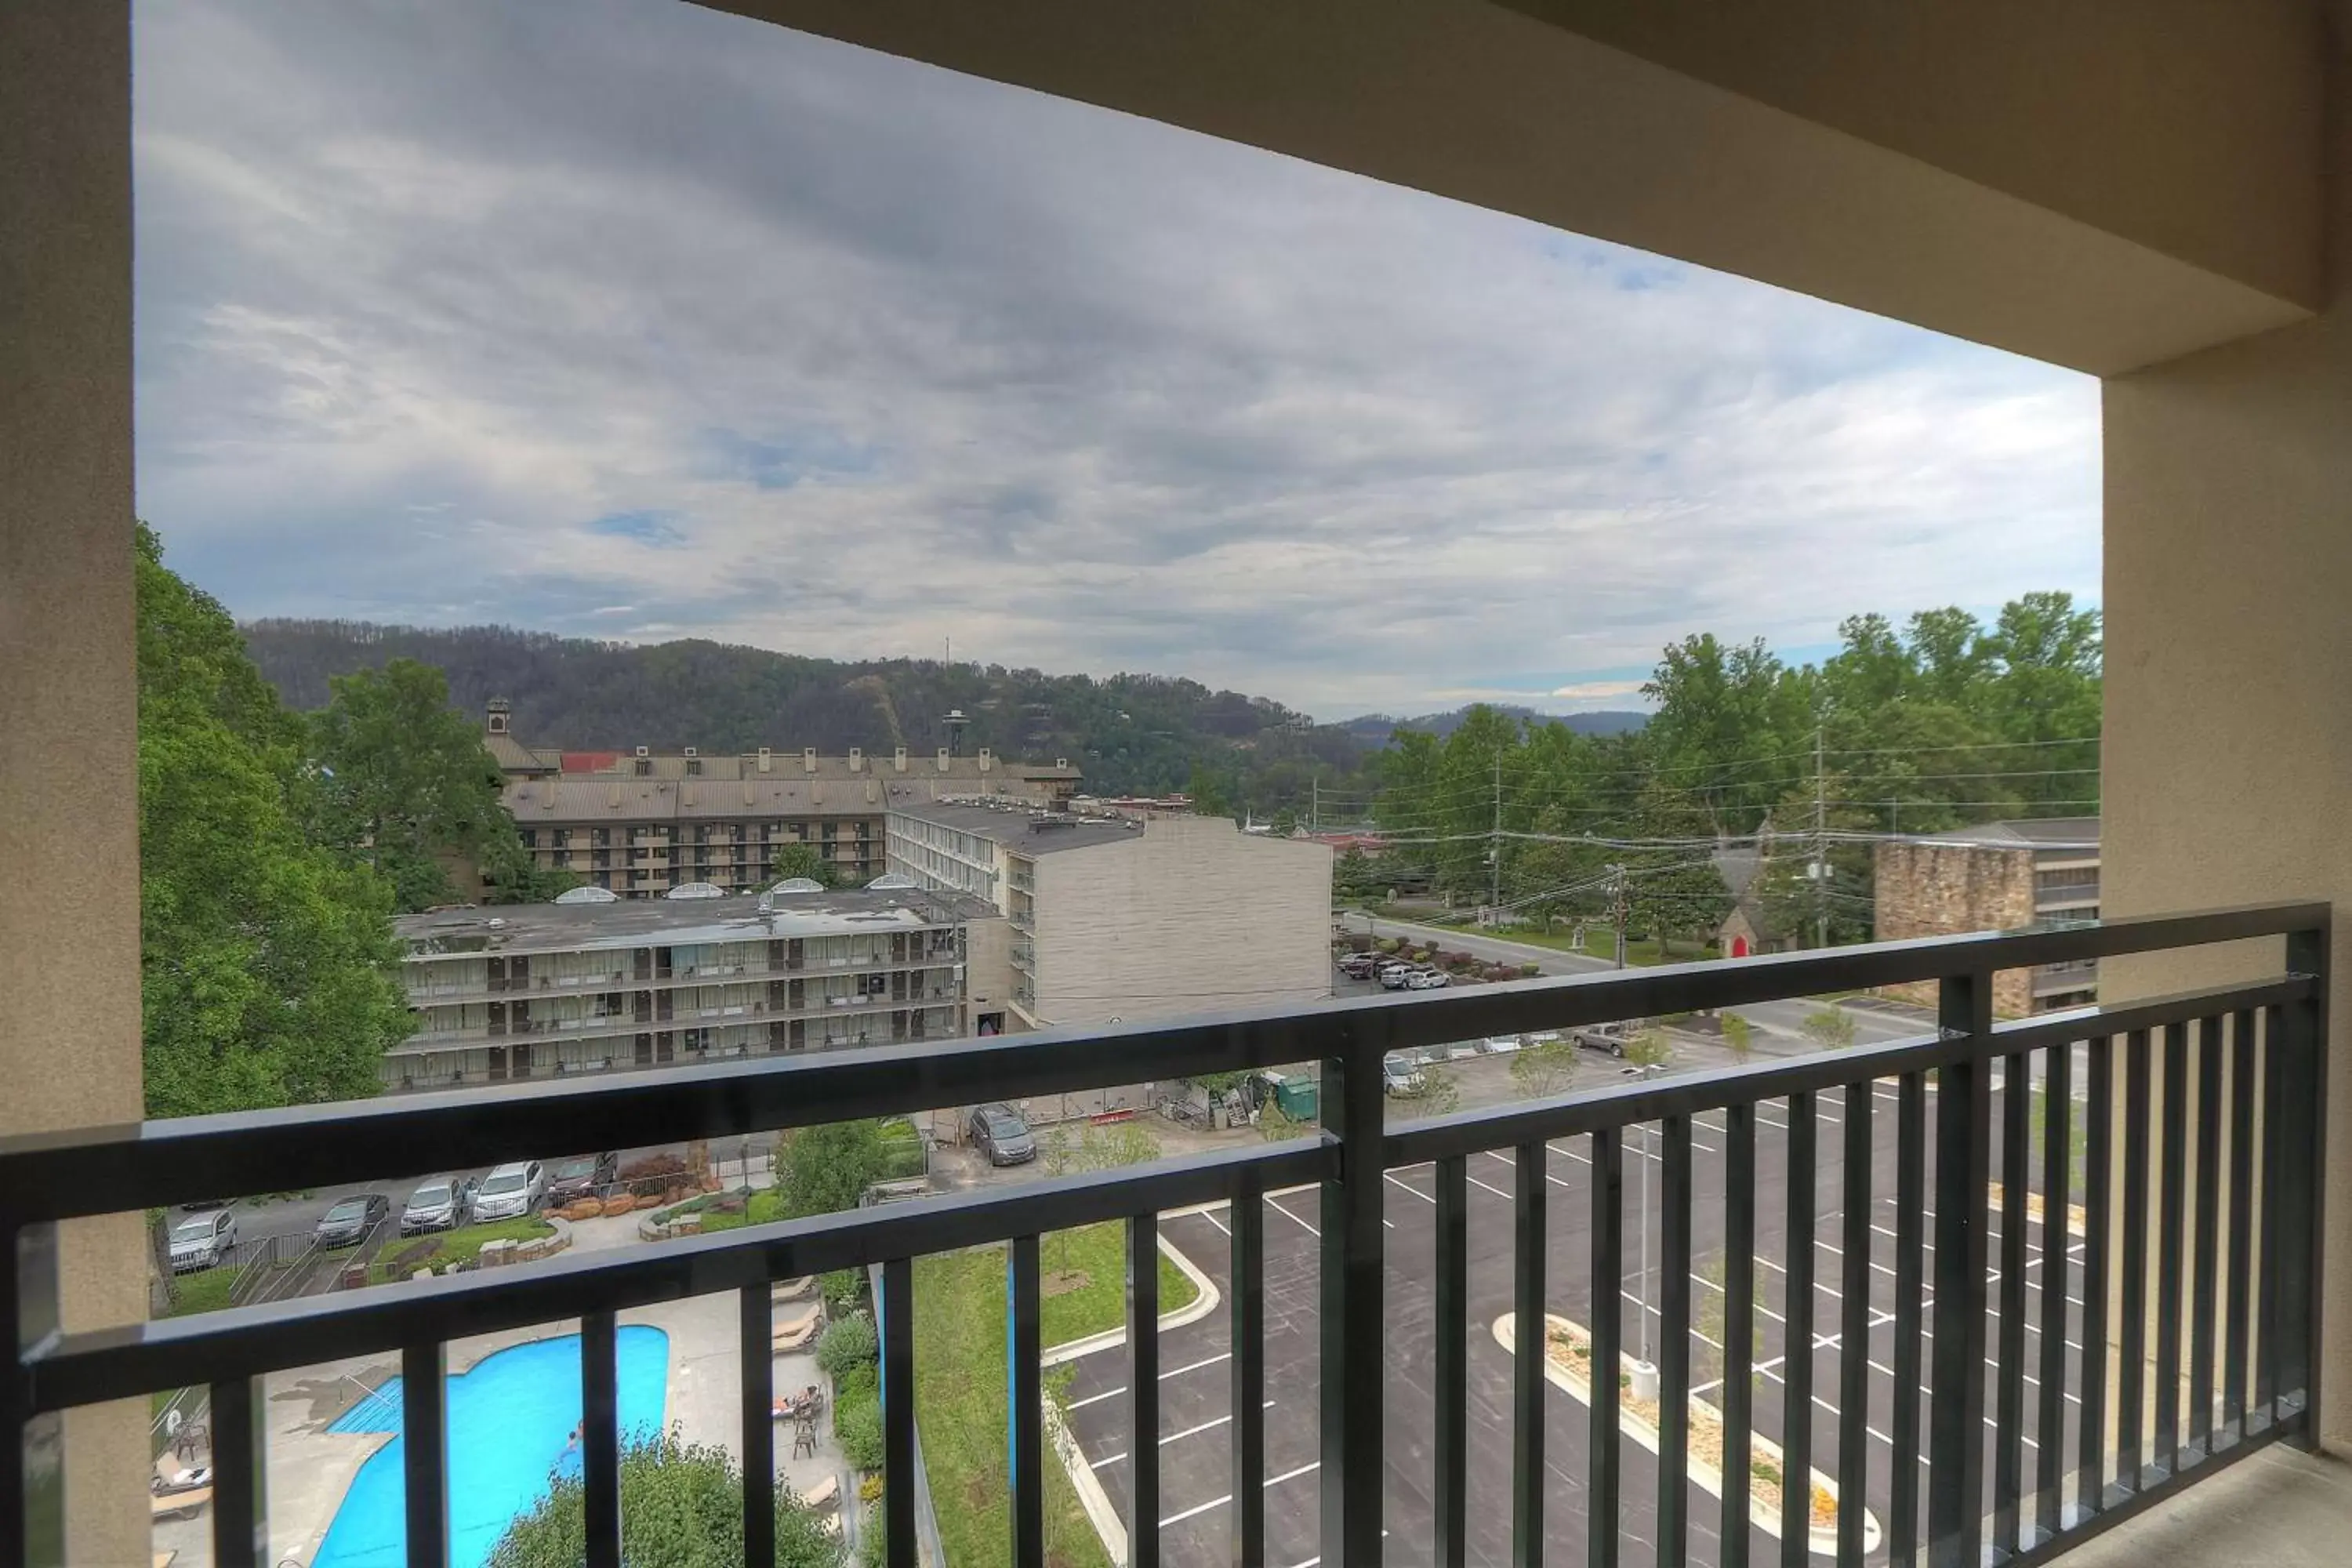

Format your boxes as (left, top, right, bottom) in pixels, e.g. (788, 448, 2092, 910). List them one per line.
(2053, 1443, 2352, 1568)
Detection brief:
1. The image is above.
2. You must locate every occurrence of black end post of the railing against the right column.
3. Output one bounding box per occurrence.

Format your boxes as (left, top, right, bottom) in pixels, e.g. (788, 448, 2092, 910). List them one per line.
(2279, 928, 2328, 1450)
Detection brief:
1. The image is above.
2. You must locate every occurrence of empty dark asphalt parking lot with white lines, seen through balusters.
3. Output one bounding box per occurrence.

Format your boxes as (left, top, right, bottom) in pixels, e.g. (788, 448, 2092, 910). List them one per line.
(1049, 1083, 2082, 1568)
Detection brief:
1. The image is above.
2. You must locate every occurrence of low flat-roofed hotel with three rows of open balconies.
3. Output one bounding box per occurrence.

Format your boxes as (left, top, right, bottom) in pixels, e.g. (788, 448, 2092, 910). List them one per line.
(383, 886, 1004, 1088)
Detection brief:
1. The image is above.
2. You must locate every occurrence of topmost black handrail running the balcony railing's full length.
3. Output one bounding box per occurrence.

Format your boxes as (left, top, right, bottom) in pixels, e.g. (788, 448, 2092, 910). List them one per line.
(0, 902, 2328, 1222)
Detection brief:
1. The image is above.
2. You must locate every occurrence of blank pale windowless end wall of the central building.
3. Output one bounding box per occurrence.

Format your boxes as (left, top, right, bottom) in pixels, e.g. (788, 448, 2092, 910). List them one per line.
(1037, 815, 1331, 1025)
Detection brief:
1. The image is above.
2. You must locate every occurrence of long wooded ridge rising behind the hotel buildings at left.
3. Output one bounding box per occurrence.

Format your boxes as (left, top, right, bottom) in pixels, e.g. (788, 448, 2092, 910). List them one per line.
(245, 621, 1367, 811)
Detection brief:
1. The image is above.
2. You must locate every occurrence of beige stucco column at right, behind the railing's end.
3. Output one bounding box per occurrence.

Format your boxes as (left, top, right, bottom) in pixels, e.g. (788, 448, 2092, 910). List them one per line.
(2103, 55, 2352, 1448)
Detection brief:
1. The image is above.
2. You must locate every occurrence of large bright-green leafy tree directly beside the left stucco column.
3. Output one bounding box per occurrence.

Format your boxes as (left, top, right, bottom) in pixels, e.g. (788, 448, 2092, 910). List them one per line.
(136, 524, 414, 1116)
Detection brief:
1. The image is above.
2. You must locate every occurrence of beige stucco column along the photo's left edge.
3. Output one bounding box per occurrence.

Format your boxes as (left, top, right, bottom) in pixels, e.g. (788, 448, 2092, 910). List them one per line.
(0, 0, 148, 1563)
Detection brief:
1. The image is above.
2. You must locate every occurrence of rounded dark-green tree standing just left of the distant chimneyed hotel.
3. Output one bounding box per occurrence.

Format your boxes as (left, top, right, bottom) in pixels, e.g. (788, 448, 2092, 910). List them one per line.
(306, 659, 560, 909)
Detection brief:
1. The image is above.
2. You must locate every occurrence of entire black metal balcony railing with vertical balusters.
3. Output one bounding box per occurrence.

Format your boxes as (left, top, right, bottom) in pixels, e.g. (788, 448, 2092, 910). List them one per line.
(0, 905, 2328, 1568)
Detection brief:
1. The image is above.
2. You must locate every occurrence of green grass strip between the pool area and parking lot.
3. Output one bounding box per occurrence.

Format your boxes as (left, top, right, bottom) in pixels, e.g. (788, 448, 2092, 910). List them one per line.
(915, 1225, 1195, 1568)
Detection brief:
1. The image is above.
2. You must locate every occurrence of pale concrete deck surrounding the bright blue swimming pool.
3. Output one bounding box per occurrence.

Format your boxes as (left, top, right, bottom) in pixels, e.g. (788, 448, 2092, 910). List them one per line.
(140, 1295, 849, 1568)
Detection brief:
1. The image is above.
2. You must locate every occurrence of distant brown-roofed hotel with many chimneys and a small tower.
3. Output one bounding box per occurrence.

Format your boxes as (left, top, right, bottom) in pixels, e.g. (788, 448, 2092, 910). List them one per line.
(482, 699, 1080, 898)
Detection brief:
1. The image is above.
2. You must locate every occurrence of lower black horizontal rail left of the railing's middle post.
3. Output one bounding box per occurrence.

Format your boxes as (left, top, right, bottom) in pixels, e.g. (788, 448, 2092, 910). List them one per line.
(24, 1138, 1336, 1410)
